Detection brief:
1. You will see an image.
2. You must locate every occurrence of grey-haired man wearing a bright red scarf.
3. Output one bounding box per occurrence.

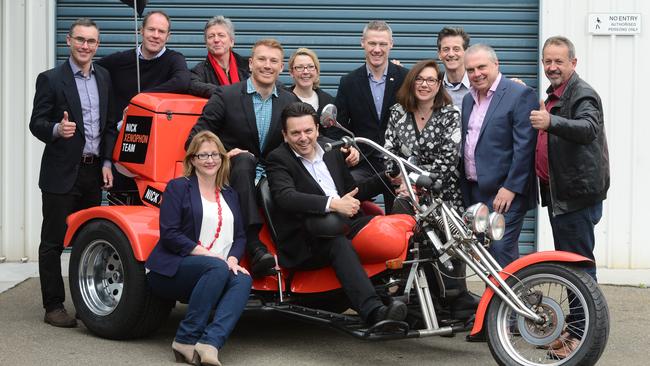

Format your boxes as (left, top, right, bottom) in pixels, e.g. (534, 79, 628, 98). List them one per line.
(190, 15, 250, 98)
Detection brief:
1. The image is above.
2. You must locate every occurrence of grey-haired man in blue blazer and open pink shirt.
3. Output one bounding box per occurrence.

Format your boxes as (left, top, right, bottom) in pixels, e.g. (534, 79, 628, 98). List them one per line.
(460, 44, 539, 266)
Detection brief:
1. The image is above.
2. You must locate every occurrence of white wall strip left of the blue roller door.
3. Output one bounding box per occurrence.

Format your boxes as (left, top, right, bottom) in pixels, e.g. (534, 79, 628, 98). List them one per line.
(0, 0, 55, 260)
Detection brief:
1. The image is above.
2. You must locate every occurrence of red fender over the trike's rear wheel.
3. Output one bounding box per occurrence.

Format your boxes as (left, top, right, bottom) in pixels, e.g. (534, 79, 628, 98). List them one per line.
(63, 206, 160, 262)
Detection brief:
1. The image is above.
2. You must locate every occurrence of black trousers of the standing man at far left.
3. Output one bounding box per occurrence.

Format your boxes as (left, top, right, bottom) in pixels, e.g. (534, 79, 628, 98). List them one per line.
(38, 161, 103, 312)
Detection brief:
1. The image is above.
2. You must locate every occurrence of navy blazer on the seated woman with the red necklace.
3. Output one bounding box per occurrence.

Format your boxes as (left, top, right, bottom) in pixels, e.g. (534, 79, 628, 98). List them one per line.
(145, 175, 246, 277)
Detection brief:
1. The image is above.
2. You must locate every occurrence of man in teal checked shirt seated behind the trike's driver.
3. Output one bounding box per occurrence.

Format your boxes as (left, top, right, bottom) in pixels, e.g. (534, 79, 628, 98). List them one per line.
(185, 39, 298, 277)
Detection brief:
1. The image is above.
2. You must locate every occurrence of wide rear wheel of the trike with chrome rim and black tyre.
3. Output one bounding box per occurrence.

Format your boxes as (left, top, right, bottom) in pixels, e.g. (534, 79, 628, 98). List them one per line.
(69, 220, 174, 339)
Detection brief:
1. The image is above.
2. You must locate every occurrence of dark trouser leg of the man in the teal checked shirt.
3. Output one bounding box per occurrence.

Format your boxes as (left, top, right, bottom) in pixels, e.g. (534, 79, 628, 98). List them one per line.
(230, 153, 262, 255)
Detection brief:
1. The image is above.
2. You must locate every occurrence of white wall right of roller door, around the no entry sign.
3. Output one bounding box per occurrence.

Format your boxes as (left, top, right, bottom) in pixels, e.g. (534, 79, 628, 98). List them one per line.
(538, 0, 650, 284)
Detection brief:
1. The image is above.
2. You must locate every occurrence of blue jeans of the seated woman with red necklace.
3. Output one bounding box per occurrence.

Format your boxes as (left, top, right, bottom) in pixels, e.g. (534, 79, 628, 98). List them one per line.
(147, 256, 252, 349)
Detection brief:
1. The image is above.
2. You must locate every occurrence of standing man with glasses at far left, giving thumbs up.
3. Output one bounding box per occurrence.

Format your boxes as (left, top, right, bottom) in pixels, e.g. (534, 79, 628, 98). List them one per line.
(29, 18, 117, 327)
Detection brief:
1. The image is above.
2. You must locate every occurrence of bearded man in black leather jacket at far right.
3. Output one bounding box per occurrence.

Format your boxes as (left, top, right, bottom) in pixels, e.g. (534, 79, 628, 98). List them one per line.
(530, 36, 609, 280)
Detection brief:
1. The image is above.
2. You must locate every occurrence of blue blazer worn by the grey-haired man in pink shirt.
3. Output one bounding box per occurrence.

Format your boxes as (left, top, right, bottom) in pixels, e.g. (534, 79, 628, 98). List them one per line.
(461, 75, 539, 210)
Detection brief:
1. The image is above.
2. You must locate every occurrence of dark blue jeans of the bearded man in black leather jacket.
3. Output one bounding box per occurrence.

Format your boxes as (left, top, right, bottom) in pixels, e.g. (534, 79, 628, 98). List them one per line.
(548, 201, 603, 281)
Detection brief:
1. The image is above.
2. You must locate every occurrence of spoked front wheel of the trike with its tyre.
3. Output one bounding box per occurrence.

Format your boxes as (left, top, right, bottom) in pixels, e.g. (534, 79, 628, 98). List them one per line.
(486, 263, 609, 365)
